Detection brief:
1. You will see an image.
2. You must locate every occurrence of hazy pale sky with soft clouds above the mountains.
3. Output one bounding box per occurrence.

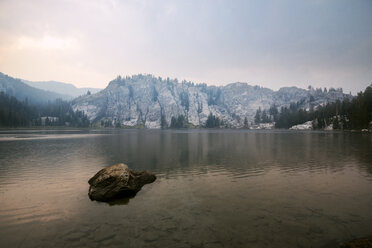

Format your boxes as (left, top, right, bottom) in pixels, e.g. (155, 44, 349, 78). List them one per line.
(0, 0, 372, 94)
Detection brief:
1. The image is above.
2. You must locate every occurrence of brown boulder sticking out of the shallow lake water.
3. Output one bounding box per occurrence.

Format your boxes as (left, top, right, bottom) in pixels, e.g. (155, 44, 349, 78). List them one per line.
(88, 164, 156, 202)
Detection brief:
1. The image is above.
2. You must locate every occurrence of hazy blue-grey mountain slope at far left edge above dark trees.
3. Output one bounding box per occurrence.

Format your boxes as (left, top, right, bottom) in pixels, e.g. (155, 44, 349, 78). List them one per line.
(0, 72, 67, 104)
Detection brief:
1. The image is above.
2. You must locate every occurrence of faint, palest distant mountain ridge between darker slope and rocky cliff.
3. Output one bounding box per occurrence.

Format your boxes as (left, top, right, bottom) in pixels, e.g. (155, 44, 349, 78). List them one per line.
(22, 80, 101, 100)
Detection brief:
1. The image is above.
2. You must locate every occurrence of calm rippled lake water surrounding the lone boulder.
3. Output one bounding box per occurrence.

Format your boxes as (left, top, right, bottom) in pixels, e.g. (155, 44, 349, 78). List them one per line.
(0, 130, 372, 248)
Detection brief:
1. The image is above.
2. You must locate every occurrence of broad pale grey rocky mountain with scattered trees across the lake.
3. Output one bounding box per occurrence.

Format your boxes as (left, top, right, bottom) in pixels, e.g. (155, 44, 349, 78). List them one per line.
(72, 74, 352, 128)
